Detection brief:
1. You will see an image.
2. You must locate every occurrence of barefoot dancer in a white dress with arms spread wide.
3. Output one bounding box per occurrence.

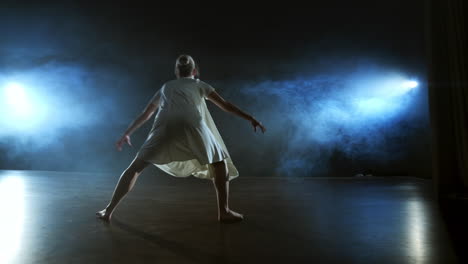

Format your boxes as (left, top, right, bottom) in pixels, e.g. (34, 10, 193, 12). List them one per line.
(96, 55, 266, 222)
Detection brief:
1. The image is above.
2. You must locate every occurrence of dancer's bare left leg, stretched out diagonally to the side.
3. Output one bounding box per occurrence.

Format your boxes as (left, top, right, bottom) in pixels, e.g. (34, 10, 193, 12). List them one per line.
(96, 158, 150, 221)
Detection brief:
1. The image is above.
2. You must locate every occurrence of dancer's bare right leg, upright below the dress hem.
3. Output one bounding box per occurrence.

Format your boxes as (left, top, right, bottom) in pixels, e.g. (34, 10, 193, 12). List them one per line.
(211, 160, 243, 222)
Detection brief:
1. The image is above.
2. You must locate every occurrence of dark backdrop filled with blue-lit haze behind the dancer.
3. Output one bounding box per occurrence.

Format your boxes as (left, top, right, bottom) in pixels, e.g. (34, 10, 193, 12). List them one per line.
(0, 0, 431, 177)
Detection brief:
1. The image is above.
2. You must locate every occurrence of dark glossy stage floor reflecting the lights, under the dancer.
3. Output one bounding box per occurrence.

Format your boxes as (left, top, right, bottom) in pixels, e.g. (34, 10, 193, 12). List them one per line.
(0, 171, 457, 264)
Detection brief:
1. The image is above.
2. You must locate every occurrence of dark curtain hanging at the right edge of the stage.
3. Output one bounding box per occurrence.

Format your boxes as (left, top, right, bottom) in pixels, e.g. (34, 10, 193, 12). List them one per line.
(426, 0, 468, 199)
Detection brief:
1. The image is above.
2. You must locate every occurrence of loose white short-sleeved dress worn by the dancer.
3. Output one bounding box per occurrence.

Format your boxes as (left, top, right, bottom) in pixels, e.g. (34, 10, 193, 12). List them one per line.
(137, 77, 239, 180)
